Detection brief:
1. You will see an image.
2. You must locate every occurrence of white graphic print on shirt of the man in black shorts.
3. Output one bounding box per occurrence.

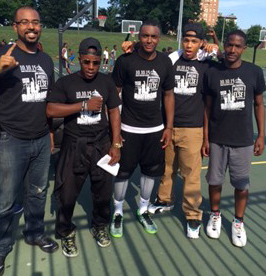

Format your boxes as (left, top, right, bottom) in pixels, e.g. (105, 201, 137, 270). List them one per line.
(134, 70, 160, 101)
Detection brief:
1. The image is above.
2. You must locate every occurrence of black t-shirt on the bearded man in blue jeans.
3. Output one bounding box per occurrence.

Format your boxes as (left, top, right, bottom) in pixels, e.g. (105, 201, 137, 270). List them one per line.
(0, 45, 54, 139)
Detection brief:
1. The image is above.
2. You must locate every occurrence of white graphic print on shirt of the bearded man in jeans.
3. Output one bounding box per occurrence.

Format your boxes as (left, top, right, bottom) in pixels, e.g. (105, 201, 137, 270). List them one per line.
(20, 65, 48, 102)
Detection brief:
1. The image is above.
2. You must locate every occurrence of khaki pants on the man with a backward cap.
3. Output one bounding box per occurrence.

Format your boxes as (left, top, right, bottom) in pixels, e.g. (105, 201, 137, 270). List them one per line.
(157, 128, 203, 220)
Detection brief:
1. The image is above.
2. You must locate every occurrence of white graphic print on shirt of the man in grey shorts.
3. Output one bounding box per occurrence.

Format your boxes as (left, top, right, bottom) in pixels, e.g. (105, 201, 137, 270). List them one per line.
(220, 78, 246, 110)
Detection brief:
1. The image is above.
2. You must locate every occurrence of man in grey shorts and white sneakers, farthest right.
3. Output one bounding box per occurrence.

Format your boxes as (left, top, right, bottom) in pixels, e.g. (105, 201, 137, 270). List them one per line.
(202, 31, 265, 247)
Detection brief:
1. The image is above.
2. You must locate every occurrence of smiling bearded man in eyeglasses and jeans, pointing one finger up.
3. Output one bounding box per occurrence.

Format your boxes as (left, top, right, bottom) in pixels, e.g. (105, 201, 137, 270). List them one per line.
(0, 6, 58, 274)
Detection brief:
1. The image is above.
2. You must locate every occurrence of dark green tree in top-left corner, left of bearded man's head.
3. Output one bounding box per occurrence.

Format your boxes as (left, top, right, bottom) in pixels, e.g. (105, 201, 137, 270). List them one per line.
(0, 0, 35, 25)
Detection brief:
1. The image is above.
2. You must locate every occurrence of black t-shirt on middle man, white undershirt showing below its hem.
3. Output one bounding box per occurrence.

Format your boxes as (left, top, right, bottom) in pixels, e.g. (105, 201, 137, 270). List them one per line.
(113, 51, 174, 128)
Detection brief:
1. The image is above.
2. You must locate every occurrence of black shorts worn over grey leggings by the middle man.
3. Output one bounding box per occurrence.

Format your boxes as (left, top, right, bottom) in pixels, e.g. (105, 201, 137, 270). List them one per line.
(117, 130, 165, 179)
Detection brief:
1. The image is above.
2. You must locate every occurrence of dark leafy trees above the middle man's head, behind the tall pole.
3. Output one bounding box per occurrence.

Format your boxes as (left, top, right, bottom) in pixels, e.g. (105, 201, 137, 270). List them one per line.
(108, 0, 200, 33)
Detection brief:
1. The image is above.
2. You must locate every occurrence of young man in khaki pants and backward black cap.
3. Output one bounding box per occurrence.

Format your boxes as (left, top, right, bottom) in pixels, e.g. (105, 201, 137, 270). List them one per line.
(149, 23, 215, 239)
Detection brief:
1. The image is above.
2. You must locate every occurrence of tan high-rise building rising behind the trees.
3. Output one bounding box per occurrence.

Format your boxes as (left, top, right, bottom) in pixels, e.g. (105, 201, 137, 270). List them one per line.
(199, 0, 219, 26)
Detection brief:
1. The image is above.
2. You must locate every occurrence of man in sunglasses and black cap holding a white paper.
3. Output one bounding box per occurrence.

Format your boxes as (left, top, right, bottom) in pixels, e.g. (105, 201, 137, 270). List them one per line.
(47, 38, 122, 257)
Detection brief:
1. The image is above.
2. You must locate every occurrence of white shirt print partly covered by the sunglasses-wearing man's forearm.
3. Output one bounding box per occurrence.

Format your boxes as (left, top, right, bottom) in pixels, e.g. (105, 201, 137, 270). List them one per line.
(76, 90, 101, 125)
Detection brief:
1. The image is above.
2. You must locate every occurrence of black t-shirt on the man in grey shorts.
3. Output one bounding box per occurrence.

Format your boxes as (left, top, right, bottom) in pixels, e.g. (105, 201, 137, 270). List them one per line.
(204, 61, 265, 147)
